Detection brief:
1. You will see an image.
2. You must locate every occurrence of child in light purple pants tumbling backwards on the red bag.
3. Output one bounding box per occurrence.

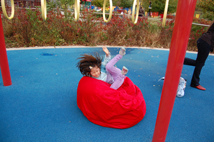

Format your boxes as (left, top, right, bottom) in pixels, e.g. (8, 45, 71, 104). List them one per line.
(77, 47, 128, 90)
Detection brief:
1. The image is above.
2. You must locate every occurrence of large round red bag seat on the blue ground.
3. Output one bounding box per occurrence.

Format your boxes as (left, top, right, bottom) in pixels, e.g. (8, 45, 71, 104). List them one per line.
(77, 76, 146, 129)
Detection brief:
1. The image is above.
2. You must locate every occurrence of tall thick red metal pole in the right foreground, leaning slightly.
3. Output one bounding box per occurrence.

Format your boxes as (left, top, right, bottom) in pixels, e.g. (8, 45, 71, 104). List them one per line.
(152, 0, 197, 142)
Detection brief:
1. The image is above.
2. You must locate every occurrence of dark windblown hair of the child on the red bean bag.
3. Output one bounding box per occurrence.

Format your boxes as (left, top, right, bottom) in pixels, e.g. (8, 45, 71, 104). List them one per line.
(77, 53, 102, 77)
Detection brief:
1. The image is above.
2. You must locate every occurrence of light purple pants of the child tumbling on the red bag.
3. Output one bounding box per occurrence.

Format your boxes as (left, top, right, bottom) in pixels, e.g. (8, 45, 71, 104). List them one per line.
(106, 54, 125, 90)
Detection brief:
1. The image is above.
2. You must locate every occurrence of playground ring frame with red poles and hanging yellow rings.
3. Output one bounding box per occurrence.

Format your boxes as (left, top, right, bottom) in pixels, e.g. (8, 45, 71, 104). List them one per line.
(0, 0, 197, 142)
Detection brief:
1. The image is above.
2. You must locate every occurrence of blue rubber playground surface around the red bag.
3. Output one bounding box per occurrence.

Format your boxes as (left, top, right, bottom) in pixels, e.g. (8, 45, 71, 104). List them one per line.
(0, 47, 214, 142)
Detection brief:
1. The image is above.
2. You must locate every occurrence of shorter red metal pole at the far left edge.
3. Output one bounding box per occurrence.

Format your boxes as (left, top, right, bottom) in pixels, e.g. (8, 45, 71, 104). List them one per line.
(0, 13, 12, 86)
